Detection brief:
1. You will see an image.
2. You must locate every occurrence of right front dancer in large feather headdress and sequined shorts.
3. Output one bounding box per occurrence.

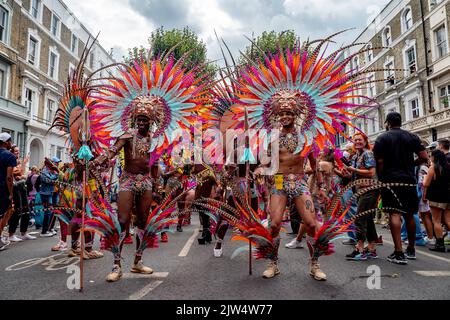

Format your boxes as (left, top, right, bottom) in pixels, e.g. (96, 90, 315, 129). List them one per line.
(229, 30, 390, 280)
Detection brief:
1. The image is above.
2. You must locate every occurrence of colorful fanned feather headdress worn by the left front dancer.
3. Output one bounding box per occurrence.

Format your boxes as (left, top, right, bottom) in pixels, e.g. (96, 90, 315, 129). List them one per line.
(94, 55, 208, 162)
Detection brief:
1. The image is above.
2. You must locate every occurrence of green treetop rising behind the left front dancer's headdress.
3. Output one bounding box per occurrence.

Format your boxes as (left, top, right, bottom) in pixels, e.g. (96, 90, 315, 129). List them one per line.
(124, 27, 215, 75)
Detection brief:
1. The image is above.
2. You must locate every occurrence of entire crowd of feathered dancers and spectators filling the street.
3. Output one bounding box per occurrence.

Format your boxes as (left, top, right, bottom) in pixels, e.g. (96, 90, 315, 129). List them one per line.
(0, 33, 450, 282)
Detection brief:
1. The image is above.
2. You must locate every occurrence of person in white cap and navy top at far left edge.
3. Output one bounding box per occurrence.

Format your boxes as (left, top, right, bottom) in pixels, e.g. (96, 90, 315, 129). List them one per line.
(0, 132, 17, 251)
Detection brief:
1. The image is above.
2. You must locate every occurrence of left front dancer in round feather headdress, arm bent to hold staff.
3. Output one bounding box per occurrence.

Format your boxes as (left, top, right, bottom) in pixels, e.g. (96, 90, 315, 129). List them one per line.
(94, 56, 211, 282)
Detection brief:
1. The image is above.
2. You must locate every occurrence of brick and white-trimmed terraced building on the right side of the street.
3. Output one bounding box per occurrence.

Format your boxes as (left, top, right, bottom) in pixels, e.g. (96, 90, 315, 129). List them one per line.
(346, 0, 450, 144)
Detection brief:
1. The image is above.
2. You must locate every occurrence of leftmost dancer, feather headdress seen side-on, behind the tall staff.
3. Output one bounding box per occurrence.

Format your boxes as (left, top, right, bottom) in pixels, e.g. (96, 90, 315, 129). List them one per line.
(49, 40, 109, 259)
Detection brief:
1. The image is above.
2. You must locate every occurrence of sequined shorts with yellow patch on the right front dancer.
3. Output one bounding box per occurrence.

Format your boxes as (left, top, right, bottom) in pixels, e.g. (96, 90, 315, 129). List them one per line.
(269, 173, 311, 198)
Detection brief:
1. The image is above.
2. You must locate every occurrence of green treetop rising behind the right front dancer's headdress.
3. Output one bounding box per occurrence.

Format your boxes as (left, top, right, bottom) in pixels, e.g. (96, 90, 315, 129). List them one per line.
(240, 30, 299, 62)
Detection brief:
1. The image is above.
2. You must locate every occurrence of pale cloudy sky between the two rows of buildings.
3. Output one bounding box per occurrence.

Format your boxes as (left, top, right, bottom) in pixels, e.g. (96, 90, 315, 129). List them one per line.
(64, 0, 389, 60)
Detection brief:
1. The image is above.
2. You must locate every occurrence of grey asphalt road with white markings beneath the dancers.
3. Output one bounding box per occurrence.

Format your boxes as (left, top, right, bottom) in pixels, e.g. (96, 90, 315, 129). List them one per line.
(0, 217, 450, 300)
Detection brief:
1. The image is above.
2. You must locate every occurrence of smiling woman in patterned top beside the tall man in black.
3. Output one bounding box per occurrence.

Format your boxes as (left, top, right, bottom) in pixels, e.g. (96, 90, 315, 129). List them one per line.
(344, 133, 379, 261)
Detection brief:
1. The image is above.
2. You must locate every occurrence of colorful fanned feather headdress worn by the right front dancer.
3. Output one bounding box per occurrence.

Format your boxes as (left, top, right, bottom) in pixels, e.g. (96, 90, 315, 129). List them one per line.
(236, 32, 384, 155)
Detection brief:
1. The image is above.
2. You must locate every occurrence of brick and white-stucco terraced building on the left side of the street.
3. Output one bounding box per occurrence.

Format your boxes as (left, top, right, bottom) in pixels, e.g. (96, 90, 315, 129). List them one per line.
(0, 0, 115, 166)
